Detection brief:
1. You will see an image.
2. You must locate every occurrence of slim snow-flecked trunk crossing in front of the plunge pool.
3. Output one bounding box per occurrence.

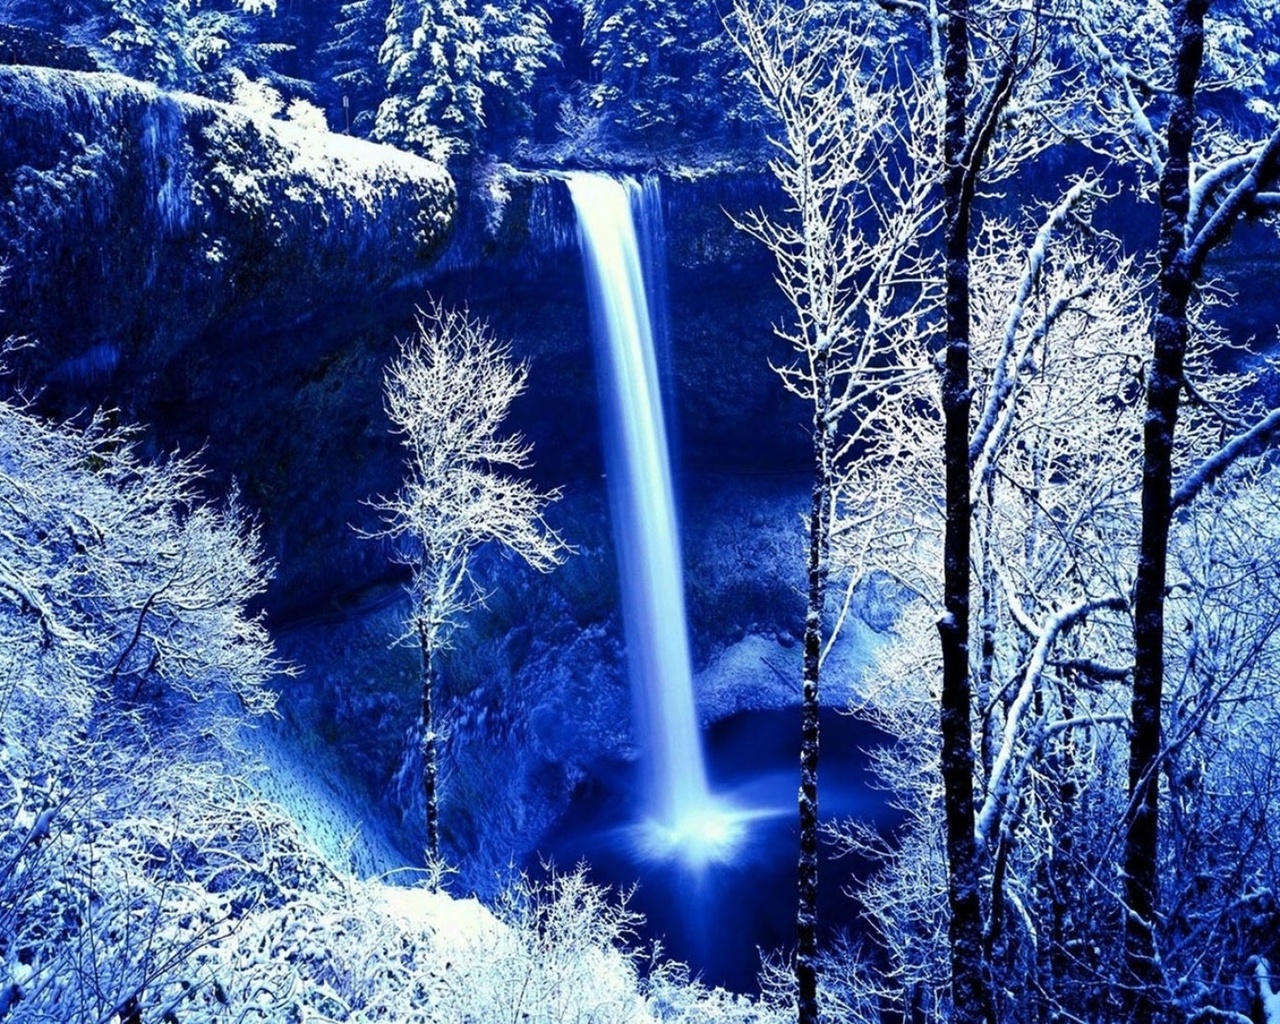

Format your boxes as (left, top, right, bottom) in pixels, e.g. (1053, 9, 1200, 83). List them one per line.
(795, 355, 832, 1024)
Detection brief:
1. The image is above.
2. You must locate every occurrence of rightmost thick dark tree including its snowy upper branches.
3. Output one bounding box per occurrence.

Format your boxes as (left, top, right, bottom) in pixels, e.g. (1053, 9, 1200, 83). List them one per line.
(1083, 0, 1280, 1019)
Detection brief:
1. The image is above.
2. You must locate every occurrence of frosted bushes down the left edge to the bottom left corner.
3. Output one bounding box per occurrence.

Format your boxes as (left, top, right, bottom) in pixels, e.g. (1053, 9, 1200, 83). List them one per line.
(0, 389, 293, 1020)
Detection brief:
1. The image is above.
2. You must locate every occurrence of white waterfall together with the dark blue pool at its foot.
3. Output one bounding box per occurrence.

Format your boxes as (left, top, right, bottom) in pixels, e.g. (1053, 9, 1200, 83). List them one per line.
(552, 173, 901, 991)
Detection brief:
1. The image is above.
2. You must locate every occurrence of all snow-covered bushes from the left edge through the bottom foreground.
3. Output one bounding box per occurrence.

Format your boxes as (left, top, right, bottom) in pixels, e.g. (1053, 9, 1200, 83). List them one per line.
(0, 389, 781, 1024)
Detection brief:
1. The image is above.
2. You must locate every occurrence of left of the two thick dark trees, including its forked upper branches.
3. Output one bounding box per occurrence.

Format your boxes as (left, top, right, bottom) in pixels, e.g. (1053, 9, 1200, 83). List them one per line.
(928, 0, 1070, 1024)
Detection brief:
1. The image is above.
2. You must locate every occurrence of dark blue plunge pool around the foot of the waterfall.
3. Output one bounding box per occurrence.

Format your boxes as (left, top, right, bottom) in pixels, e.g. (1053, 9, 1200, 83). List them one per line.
(539, 708, 897, 992)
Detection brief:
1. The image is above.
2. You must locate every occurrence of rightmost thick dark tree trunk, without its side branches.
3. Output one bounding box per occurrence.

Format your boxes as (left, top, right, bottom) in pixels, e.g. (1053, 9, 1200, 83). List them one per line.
(1123, 0, 1208, 1020)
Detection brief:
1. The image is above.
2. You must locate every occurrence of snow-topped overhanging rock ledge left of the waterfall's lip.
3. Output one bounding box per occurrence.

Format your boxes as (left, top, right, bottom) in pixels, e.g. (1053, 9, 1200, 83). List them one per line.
(0, 68, 454, 419)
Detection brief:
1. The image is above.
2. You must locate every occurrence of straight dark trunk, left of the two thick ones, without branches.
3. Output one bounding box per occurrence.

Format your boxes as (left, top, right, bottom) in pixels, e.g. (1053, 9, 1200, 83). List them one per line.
(938, 0, 995, 1024)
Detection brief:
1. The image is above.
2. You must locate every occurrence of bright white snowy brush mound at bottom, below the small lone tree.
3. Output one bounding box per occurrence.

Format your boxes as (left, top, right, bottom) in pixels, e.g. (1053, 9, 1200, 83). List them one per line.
(198, 867, 790, 1024)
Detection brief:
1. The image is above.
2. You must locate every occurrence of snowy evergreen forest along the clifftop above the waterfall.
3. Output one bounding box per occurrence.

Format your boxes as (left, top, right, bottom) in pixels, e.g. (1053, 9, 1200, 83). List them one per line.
(0, 0, 759, 163)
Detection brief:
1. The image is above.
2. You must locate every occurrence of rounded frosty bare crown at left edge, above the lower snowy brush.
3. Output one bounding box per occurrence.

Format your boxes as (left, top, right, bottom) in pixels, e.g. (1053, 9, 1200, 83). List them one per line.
(0, 402, 279, 714)
